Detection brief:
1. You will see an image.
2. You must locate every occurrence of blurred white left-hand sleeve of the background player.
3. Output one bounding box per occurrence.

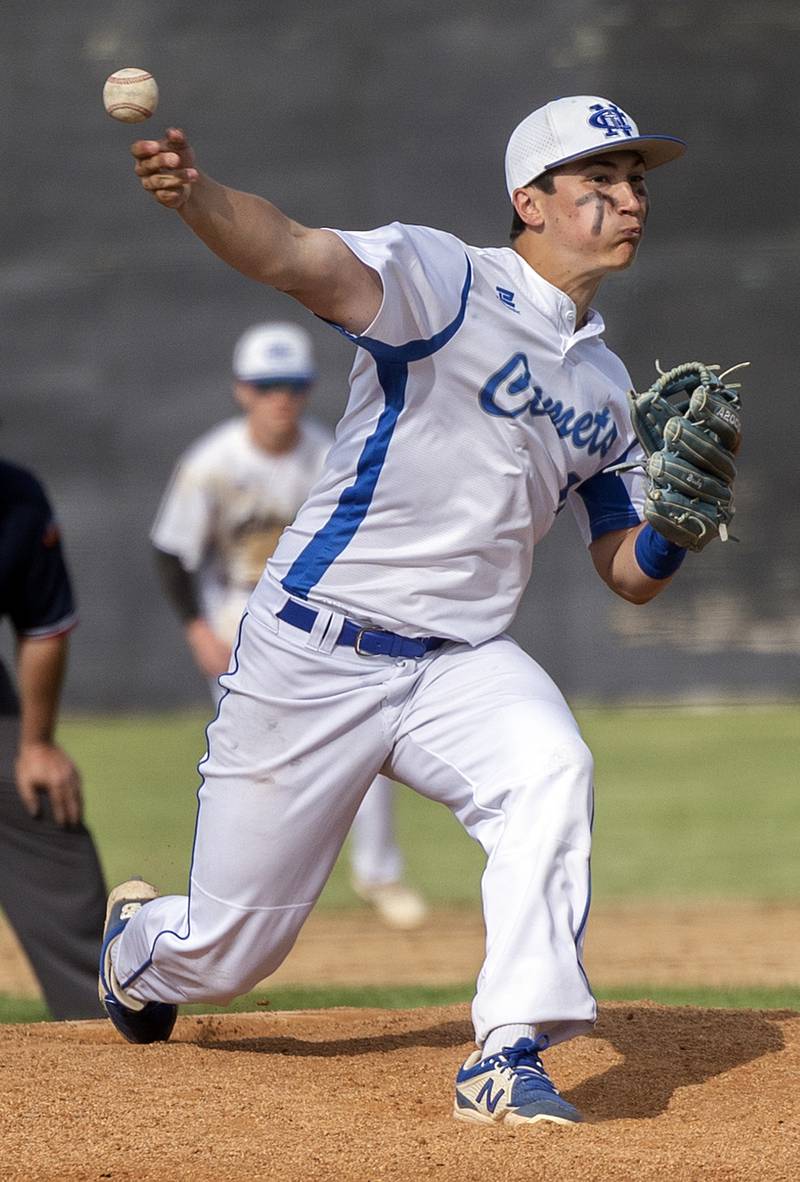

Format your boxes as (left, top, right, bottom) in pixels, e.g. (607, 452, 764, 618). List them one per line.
(150, 457, 214, 571)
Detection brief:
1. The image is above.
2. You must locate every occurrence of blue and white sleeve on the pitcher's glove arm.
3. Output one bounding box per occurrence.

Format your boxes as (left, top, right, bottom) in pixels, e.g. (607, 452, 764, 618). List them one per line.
(567, 428, 648, 546)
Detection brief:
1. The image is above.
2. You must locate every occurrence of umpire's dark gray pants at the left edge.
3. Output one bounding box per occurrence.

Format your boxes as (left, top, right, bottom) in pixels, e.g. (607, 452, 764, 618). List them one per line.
(0, 717, 105, 1019)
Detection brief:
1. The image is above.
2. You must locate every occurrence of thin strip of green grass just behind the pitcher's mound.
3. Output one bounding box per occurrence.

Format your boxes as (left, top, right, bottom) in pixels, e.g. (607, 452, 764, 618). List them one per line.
(0, 985, 800, 1024)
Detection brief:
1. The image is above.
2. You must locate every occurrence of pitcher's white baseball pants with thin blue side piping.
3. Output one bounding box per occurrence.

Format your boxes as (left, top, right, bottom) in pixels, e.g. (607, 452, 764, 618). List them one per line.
(116, 585, 596, 1045)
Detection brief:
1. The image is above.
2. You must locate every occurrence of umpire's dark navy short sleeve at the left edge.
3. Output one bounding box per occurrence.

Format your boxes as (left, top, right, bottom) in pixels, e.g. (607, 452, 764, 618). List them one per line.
(8, 486, 77, 637)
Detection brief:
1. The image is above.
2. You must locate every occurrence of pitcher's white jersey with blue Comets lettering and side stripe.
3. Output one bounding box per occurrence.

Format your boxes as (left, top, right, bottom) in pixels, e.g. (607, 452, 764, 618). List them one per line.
(264, 223, 644, 644)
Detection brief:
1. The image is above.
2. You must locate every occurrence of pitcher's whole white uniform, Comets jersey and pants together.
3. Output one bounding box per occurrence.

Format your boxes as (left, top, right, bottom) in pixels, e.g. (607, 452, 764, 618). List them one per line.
(115, 225, 643, 1045)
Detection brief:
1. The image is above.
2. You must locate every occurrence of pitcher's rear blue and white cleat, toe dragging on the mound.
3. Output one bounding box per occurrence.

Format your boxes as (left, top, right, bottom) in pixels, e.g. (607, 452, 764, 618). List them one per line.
(99, 878, 177, 1043)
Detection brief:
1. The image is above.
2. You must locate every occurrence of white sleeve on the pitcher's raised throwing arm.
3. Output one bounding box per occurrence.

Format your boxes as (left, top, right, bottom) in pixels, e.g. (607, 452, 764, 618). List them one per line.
(333, 222, 471, 348)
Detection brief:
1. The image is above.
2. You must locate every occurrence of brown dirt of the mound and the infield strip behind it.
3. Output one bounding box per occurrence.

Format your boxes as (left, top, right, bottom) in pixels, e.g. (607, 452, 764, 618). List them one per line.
(0, 903, 800, 1182)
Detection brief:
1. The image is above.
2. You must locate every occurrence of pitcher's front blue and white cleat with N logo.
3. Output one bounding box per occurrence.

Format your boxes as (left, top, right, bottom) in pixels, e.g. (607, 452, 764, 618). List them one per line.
(453, 1038, 583, 1124)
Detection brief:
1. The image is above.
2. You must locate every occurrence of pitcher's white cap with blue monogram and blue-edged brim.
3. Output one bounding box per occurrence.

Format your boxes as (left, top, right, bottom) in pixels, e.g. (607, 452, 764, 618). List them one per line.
(506, 95, 687, 197)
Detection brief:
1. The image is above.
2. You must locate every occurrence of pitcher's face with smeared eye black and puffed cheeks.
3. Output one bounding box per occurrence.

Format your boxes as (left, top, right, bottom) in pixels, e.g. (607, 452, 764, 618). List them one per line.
(540, 151, 649, 273)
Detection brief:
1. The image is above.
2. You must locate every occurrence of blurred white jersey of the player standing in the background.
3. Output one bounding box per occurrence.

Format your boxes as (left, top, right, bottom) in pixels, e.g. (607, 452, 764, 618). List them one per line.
(150, 416, 332, 643)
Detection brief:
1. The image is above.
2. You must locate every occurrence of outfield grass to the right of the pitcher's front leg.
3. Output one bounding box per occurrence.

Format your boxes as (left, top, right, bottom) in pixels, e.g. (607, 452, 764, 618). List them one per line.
(580, 706, 800, 898)
